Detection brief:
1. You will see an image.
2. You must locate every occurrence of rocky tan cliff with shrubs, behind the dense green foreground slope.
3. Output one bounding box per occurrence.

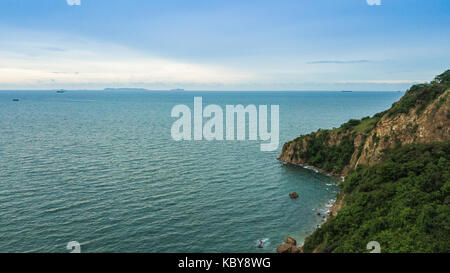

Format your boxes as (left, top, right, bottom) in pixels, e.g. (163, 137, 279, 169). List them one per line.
(278, 71, 450, 176)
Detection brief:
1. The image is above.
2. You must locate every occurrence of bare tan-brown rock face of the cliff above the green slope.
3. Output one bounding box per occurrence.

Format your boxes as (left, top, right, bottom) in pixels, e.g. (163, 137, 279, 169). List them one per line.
(278, 89, 450, 176)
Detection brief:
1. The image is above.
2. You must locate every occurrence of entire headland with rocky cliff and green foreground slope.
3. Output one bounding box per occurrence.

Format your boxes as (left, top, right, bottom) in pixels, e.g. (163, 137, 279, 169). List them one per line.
(277, 70, 450, 253)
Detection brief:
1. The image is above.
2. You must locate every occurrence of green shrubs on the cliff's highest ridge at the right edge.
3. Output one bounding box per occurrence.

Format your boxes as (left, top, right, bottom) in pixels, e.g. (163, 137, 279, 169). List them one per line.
(388, 70, 450, 116)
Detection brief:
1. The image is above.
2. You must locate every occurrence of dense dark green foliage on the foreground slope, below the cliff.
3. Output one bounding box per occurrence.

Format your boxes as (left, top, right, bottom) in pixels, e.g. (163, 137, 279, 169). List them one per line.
(303, 141, 450, 252)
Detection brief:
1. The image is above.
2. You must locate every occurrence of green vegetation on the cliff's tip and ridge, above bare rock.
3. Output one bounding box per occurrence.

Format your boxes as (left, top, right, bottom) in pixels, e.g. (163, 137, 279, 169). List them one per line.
(286, 70, 450, 174)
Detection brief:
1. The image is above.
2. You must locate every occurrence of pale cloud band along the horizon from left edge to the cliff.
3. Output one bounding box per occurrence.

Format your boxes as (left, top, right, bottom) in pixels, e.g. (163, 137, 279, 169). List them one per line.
(0, 26, 432, 91)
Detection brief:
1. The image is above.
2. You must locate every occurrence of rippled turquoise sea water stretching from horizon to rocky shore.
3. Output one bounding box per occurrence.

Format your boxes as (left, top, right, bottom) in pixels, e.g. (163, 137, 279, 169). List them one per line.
(0, 91, 403, 252)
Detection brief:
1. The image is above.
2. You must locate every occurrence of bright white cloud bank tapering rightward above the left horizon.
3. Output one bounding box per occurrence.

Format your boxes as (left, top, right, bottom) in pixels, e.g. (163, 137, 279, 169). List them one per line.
(0, 32, 253, 88)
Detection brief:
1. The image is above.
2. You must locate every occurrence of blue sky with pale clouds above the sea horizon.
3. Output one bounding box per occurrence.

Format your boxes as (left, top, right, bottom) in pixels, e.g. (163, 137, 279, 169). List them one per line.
(0, 0, 450, 91)
